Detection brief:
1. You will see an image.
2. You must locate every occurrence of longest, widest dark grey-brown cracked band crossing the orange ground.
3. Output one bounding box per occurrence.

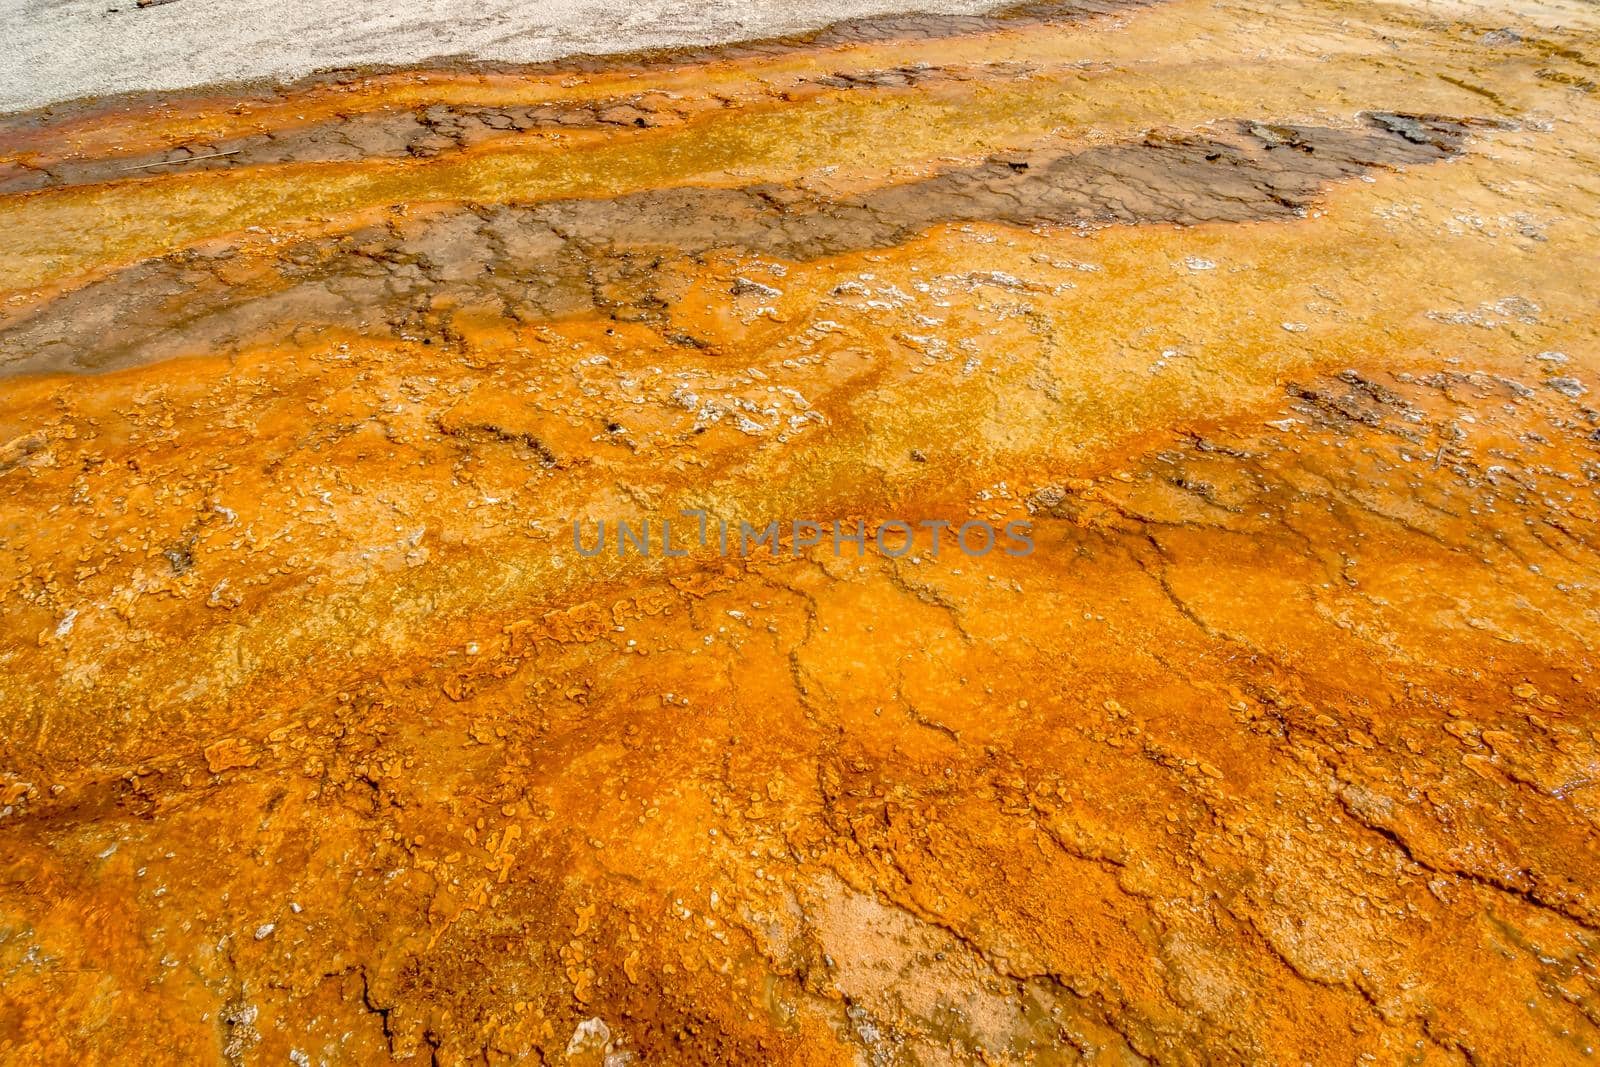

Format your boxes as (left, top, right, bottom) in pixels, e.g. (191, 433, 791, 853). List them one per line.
(0, 112, 1480, 374)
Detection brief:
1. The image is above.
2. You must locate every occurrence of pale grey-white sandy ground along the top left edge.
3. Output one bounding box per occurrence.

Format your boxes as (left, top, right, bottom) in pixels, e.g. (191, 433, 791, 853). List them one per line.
(0, 0, 998, 110)
